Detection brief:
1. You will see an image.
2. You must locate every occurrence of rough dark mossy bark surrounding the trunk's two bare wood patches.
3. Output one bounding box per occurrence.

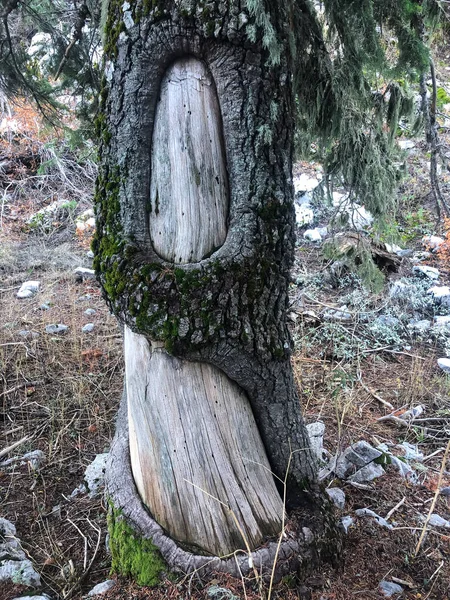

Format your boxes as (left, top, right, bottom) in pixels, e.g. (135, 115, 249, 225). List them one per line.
(95, 0, 342, 572)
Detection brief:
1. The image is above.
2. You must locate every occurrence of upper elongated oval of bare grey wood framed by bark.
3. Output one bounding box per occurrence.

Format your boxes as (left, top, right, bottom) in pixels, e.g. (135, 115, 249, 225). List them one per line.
(150, 57, 229, 263)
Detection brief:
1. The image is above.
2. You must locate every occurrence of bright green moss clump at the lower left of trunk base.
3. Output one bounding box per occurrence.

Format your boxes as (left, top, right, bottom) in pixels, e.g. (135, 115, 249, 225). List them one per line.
(108, 506, 167, 586)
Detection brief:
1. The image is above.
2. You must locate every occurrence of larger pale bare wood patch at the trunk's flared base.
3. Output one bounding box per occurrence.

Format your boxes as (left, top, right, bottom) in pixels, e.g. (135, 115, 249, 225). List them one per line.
(125, 328, 283, 556)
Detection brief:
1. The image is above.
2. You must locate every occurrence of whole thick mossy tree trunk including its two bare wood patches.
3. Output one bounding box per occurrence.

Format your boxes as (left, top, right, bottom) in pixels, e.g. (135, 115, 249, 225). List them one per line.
(95, 0, 342, 574)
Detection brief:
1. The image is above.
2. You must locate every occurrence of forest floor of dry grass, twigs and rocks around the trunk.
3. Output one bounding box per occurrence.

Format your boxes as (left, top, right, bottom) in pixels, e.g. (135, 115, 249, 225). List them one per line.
(0, 42, 450, 600)
